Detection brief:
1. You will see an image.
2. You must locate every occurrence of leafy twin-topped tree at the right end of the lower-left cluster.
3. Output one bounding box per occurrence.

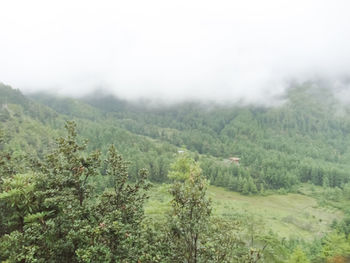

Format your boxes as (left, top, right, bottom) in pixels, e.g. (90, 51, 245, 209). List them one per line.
(77, 145, 150, 262)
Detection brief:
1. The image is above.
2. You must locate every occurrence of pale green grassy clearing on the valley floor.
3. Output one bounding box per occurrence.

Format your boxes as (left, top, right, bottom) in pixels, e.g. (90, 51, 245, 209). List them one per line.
(146, 185, 343, 240)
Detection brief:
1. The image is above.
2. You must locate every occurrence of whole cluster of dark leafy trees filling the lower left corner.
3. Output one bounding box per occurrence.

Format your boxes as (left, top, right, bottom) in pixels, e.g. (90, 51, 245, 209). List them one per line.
(0, 122, 149, 262)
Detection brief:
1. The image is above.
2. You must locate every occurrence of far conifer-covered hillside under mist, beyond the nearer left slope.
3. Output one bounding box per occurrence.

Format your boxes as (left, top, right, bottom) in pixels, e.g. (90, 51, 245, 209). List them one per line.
(33, 84, 350, 192)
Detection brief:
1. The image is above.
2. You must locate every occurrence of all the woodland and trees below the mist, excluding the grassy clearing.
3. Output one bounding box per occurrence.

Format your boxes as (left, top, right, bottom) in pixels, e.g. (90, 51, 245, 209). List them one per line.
(0, 83, 350, 263)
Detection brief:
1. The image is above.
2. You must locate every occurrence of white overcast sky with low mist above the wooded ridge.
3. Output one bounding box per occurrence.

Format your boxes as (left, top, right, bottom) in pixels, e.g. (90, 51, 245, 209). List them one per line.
(0, 0, 350, 103)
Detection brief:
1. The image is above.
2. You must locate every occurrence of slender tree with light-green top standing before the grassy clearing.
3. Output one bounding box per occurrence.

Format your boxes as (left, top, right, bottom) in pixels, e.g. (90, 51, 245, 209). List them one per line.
(169, 155, 211, 263)
